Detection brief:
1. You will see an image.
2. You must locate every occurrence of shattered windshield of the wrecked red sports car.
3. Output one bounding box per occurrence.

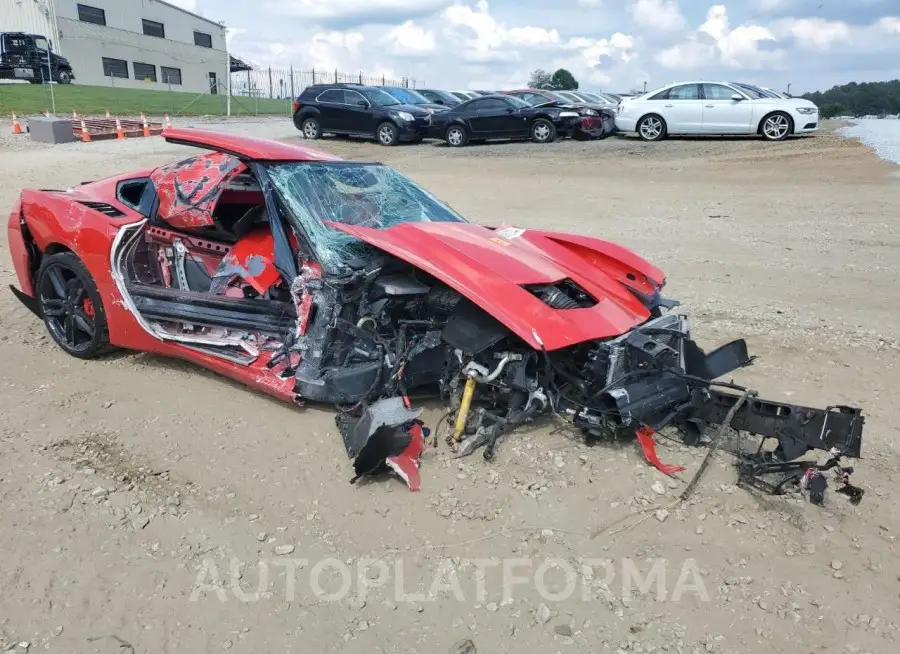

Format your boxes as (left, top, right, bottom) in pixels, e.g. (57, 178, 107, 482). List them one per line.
(268, 161, 465, 269)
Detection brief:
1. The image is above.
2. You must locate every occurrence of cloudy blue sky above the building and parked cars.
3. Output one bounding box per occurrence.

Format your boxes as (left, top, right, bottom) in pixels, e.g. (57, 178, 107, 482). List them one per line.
(168, 0, 900, 94)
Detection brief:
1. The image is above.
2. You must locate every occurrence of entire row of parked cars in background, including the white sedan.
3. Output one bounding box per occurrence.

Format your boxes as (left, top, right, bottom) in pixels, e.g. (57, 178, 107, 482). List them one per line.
(293, 81, 819, 147)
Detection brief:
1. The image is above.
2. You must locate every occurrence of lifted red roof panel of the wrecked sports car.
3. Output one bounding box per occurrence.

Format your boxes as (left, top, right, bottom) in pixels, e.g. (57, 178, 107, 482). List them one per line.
(162, 127, 343, 161)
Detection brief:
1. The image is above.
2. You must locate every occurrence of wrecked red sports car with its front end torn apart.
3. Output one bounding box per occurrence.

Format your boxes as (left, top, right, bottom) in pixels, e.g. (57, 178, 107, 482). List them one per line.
(9, 129, 863, 501)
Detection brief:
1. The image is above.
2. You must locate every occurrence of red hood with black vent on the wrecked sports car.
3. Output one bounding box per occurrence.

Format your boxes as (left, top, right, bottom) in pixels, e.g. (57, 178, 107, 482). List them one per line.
(332, 222, 663, 350)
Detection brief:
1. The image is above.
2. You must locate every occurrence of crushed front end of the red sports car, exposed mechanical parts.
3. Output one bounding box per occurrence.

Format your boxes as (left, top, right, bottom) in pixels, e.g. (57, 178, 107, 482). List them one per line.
(448, 299, 864, 503)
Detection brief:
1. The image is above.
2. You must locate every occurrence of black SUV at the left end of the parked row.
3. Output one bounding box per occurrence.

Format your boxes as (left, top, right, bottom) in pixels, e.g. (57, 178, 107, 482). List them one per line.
(294, 84, 431, 145)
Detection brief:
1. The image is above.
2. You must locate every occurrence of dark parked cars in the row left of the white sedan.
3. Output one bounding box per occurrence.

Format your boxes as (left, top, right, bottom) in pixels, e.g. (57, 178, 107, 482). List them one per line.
(293, 84, 615, 147)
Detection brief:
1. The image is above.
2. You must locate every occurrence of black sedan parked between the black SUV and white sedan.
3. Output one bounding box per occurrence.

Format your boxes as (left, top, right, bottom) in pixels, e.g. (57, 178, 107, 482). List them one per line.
(431, 95, 581, 148)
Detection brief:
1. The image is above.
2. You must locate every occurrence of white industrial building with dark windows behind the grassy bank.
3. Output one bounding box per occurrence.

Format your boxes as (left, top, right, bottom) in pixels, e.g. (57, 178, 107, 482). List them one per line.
(0, 0, 228, 93)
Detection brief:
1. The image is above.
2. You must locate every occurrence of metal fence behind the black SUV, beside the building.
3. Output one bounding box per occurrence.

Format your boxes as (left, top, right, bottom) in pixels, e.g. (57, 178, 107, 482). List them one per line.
(225, 68, 424, 100)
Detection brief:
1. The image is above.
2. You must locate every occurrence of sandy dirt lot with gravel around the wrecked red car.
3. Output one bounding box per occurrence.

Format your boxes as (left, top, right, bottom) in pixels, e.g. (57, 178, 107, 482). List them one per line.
(0, 121, 900, 654)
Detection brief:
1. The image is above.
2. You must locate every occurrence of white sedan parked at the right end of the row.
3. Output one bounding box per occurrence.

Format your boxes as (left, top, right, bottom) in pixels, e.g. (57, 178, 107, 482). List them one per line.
(616, 81, 819, 141)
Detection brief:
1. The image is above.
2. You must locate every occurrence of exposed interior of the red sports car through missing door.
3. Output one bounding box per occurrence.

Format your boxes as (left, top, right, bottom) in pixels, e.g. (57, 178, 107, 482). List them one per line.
(117, 167, 288, 365)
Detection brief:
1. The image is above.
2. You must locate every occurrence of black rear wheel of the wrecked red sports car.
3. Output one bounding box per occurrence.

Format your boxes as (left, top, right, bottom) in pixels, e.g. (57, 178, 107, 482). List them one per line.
(35, 252, 110, 359)
